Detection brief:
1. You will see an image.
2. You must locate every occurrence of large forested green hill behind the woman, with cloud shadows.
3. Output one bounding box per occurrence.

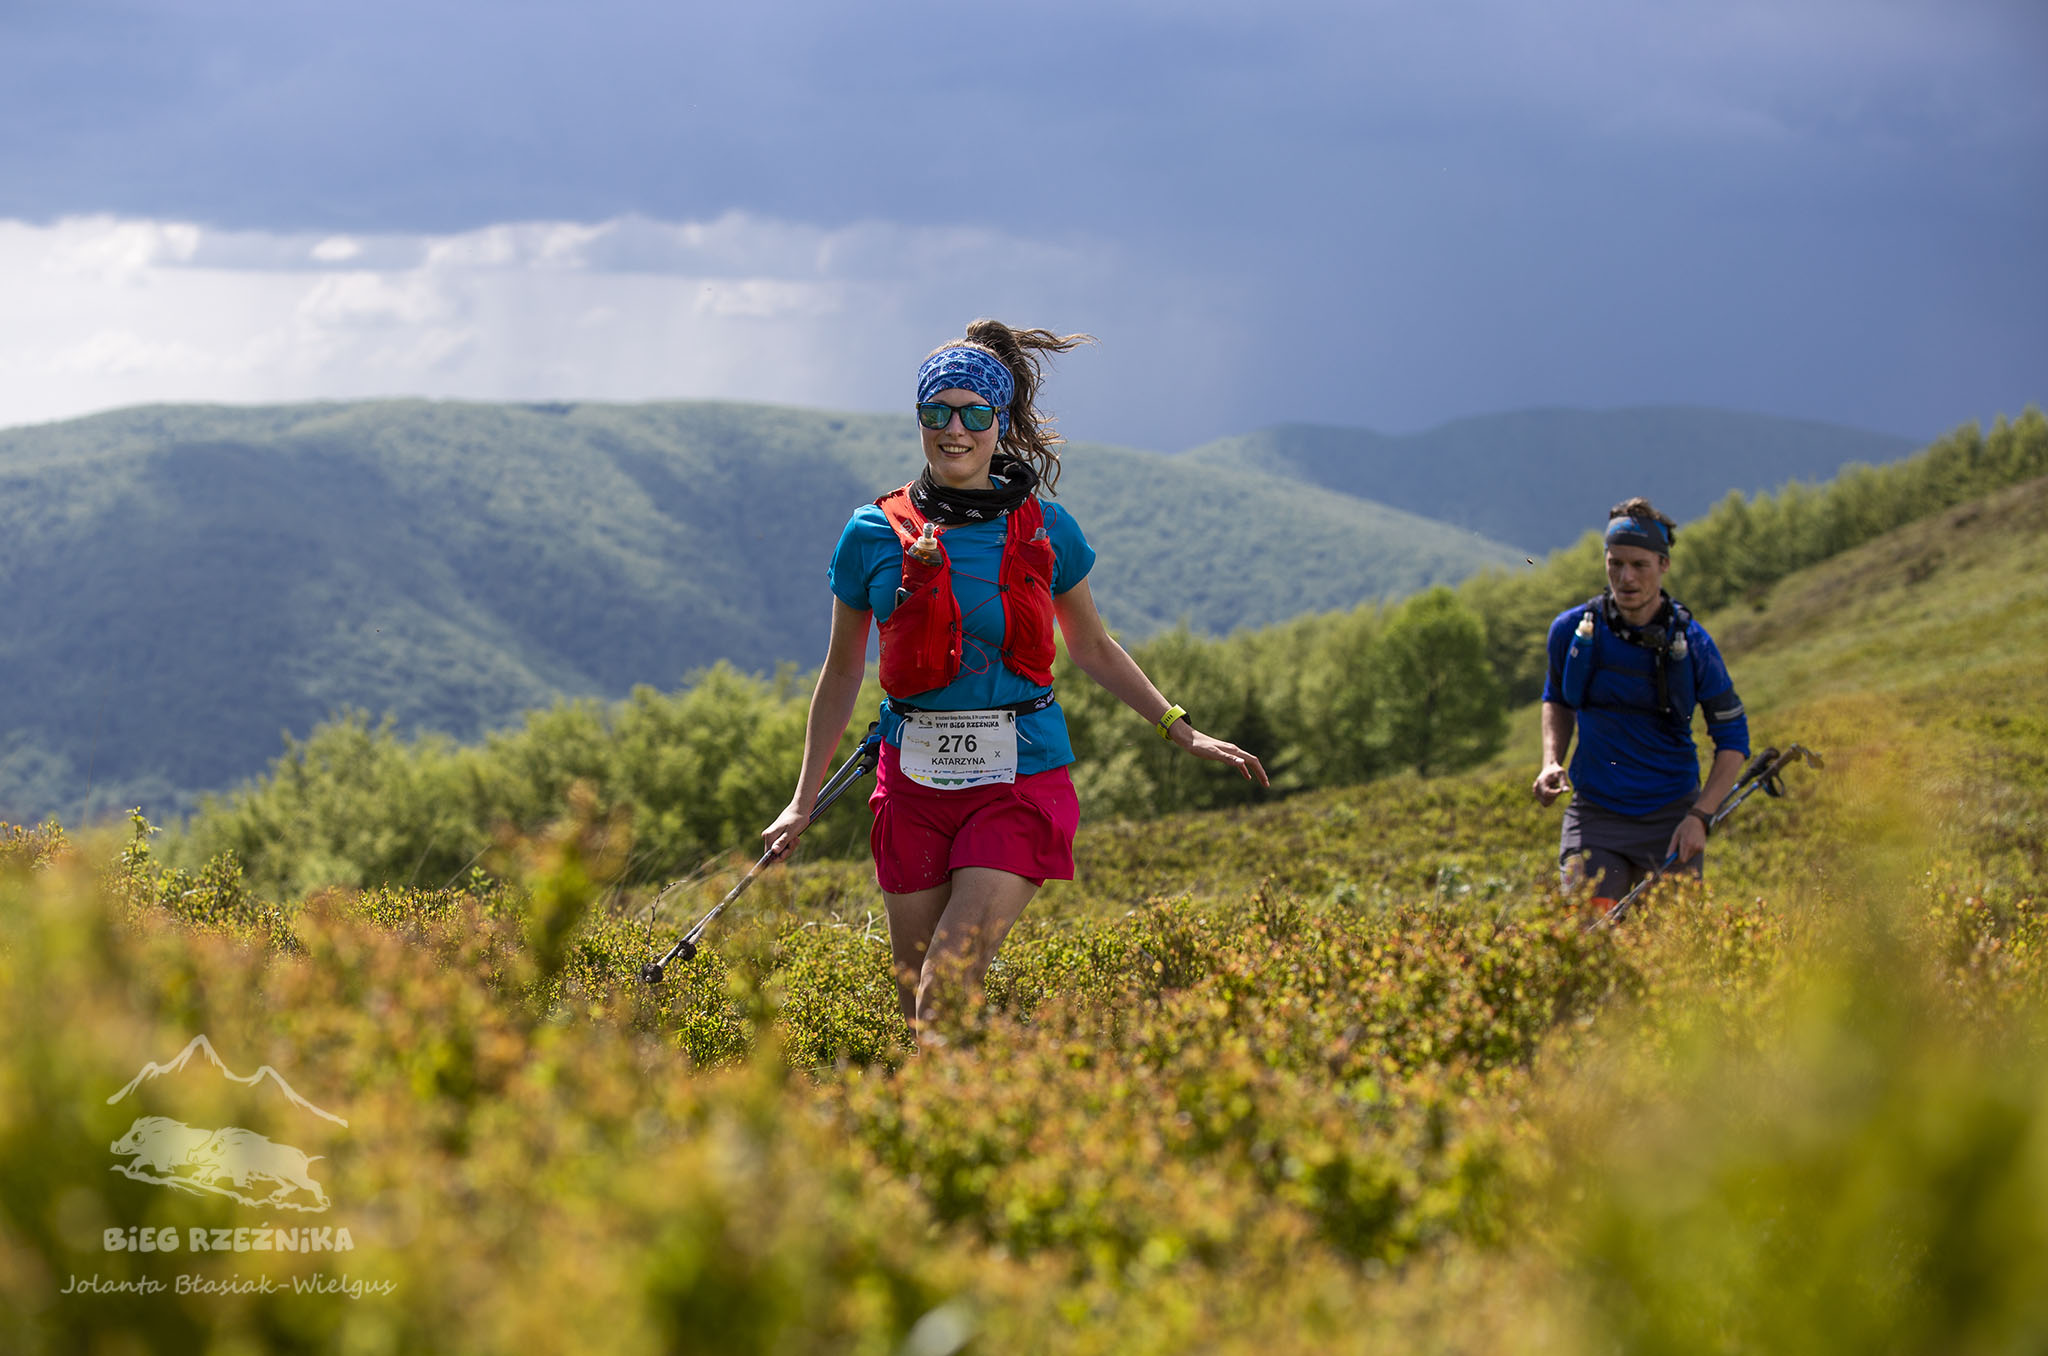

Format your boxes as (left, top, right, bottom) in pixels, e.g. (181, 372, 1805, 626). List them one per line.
(0, 401, 1520, 821)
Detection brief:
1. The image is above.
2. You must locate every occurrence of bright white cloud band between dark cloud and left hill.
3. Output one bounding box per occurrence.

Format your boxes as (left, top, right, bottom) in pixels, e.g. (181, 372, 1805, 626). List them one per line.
(0, 213, 1157, 424)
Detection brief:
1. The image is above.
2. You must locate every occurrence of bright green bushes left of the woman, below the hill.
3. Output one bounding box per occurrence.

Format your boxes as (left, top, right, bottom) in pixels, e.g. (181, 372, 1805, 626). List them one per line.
(174, 664, 864, 895)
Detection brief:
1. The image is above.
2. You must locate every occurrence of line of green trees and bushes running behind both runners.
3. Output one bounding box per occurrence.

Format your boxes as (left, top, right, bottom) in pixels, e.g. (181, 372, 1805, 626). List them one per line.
(168, 408, 2048, 897)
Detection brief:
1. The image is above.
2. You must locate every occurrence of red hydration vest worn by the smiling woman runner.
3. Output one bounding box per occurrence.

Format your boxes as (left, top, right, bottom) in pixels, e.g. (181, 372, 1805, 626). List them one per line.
(874, 485, 1053, 698)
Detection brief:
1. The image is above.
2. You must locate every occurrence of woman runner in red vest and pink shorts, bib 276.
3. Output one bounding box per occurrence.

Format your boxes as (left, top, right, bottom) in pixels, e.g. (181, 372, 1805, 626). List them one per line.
(762, 320, 1268, 1041)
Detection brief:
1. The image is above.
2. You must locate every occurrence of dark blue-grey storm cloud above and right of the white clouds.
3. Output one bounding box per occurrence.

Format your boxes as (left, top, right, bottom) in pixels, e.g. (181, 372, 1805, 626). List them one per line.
(0, 0, 2048, 440)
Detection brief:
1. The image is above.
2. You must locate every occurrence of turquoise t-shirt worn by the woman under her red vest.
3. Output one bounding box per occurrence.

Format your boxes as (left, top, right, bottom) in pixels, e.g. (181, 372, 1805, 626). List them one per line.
(825, 500, 1096, 776)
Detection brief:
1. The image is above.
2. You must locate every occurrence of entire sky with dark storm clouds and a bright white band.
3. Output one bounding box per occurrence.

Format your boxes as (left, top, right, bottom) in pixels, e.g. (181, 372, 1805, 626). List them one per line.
(0, 0, 2048, 451)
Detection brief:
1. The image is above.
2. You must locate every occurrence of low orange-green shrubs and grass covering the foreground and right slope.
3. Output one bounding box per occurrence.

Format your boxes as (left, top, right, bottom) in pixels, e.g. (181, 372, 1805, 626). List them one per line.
(0, 481, 2048, 1356)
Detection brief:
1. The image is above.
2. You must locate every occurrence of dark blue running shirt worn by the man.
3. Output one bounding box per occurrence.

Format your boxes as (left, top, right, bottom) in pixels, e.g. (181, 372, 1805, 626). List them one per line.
(1542, 602, 1749, 815)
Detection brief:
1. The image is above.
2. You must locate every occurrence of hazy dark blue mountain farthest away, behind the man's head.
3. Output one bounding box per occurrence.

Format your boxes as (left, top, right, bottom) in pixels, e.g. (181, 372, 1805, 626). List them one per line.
(1182, 406, 1919, 555)
